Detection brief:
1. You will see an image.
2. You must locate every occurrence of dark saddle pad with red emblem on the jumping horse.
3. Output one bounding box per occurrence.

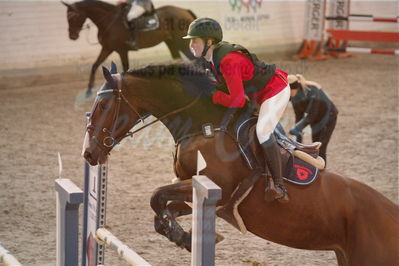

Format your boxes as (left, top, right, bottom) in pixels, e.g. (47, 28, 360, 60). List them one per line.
(237, 117, 319, 185)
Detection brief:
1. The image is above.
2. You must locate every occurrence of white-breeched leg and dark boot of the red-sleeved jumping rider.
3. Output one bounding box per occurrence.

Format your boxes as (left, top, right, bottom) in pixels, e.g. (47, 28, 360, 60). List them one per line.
(256, 86, 290, 201)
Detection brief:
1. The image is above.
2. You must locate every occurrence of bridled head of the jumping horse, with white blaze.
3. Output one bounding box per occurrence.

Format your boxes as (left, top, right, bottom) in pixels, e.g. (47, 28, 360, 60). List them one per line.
(82, 63, 140, 165)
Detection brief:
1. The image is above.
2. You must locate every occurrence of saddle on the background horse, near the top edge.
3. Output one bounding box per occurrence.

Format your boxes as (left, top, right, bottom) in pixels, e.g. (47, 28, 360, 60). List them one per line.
(123, 4, 159, 31)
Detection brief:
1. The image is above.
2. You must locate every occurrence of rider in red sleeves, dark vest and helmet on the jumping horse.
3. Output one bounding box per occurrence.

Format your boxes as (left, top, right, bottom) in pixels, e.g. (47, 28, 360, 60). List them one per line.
(183, 18, 290, 202)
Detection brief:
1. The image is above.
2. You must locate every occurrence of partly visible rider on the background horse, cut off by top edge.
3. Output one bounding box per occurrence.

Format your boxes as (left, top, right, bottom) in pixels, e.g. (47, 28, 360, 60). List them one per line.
(119, 0, 153, 50)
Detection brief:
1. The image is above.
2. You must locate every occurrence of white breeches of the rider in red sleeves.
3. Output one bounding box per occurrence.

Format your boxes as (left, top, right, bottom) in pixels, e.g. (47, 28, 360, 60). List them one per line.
(256, 85, 291, 144)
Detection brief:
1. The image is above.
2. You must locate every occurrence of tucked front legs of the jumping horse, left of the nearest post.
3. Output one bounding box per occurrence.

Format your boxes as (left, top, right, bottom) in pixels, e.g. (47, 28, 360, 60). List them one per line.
(151, 179, 192, 251)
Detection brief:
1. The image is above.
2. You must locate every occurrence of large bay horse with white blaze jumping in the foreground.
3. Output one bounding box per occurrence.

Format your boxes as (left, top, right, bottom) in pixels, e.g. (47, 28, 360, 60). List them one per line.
(82, 63, 399, 266)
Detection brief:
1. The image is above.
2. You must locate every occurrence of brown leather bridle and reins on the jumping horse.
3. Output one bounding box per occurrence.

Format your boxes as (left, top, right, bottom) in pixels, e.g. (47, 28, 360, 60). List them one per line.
(86, 73, 201, 152)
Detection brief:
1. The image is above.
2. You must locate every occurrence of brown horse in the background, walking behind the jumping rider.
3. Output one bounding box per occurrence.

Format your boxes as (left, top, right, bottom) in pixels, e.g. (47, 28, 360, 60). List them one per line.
(62, 0, 196, 95)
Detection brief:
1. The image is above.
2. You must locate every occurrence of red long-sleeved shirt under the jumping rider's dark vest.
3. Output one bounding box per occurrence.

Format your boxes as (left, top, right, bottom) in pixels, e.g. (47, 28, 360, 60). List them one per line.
(212, 52, 288, 108)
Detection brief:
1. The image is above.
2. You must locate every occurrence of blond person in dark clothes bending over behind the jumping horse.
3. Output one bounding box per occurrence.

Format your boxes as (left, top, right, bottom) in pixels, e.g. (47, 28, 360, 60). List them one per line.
(288, 74, 338, 163)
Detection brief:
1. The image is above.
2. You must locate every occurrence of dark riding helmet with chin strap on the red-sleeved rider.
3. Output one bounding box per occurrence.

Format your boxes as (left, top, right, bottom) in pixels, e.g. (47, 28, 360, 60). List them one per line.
(183, 18, 223, 56)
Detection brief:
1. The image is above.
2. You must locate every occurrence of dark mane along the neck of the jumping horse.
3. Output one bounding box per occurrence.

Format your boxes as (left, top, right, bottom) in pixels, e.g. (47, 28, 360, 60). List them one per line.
(125, 61, 215, 97)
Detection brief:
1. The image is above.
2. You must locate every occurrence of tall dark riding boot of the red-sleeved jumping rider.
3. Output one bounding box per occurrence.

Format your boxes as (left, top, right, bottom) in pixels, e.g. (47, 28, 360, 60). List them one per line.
(261, 134, 289, 202)
